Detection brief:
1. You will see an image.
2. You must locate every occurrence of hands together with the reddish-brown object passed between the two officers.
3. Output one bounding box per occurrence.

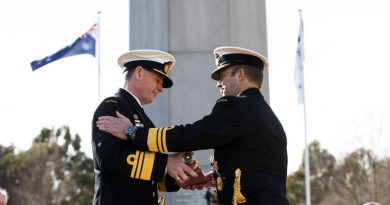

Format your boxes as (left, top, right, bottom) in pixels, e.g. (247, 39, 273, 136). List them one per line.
(167, 152, 213, 189)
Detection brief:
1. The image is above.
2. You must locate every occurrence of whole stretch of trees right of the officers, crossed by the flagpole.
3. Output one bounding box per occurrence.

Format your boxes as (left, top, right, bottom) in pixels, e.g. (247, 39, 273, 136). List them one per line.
(287, 141, 390, 205)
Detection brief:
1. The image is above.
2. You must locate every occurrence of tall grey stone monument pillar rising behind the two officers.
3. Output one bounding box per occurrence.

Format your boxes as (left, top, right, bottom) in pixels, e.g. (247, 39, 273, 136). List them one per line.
(129, 0, 272, 205)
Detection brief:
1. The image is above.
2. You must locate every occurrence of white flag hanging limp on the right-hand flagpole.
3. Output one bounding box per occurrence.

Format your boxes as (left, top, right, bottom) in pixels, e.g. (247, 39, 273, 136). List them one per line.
(295, 12, 305, 104)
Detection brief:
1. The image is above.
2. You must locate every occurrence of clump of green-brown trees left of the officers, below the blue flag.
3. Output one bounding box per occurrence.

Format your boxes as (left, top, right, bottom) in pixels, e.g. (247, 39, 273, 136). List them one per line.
(0, 126, 94, 205)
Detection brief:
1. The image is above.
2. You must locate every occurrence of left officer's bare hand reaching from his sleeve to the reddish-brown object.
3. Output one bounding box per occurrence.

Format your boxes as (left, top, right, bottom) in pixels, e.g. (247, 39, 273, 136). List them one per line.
(167, 152, 198, 187)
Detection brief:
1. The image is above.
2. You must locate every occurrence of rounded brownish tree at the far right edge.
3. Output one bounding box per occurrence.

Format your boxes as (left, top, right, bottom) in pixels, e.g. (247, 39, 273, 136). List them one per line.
(333, 148, 390, 204)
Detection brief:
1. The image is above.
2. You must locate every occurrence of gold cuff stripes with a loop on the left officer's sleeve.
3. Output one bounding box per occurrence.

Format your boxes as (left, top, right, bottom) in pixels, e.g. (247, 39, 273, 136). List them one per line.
(126, 151, 155, 180)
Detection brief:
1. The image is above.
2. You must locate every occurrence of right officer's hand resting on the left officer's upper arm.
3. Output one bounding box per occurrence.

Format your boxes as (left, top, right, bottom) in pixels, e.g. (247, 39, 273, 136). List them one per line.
(96, 111, 132, 140)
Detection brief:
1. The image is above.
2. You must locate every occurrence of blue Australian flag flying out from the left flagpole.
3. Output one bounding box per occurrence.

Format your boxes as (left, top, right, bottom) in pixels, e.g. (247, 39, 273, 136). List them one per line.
(31, 24, 97, 71)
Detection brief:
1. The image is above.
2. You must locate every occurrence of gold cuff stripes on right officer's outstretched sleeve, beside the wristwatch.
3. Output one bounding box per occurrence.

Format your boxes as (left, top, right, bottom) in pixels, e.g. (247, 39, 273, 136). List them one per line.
(147, 126, 175, 152)
